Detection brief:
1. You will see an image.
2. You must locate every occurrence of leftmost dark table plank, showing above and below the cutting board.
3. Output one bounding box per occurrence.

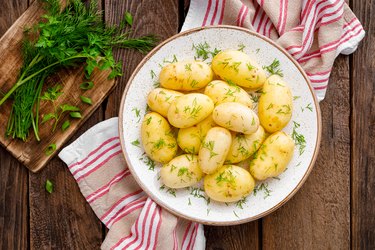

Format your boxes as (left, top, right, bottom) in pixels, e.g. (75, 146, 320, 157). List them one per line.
(0, 0, 29, 249)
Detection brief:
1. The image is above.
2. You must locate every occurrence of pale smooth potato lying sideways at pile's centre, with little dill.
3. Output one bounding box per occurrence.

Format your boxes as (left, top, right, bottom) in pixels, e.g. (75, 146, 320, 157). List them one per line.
(212, 102, 259, 134)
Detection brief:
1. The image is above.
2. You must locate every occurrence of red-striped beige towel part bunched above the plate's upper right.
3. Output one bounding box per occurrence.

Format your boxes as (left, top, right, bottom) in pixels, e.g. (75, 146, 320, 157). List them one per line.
(182, 0, 365, 101)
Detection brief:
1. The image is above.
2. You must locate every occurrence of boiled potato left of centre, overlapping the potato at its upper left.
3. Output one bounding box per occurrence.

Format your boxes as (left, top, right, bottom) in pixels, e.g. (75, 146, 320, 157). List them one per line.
(168, 93, 214, 128)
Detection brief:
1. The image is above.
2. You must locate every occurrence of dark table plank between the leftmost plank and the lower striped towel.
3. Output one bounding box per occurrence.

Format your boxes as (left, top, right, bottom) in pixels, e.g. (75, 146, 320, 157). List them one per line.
(29, 110, 103, 249)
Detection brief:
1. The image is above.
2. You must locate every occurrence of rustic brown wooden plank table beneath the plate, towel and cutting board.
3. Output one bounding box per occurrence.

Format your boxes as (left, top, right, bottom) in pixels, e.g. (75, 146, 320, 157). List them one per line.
(0, 0, 375, 249)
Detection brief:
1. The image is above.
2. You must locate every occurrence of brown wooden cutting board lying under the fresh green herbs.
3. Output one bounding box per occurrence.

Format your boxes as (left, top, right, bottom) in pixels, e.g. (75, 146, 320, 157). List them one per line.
(0, 1, 115, 172)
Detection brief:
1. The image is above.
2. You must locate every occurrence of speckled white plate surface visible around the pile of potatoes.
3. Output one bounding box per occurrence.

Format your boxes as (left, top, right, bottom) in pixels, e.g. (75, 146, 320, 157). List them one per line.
(119, 26, 321, 225)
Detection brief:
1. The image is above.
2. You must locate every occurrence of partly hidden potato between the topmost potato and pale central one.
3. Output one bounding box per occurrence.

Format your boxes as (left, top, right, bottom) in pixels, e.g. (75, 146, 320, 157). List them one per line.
(204, 80, 253, 108)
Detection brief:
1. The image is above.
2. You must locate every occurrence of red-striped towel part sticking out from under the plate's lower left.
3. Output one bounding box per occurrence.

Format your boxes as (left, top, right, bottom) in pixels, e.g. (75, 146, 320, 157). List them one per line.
(59, 118, 205, 250)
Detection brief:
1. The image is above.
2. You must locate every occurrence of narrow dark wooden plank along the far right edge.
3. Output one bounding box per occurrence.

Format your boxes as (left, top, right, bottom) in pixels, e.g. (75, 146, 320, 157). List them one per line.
(351, 0, 375, 249)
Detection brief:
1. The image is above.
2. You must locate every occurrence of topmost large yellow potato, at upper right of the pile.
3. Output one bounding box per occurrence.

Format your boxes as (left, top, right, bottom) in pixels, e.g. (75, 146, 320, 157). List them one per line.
(212, 50, 266, 89)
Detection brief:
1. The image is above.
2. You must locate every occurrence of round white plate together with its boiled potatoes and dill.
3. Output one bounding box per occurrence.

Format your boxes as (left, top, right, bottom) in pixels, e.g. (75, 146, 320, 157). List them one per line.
(119, 26, 321, 225)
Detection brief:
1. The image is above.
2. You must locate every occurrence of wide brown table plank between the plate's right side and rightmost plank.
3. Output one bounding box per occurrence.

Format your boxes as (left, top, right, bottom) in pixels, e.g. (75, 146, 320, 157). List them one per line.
(263, 56, 350, 249)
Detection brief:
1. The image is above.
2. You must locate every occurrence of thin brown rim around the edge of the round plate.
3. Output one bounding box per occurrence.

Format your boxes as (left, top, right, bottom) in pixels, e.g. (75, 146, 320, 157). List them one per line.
(118, 25, 322, 226)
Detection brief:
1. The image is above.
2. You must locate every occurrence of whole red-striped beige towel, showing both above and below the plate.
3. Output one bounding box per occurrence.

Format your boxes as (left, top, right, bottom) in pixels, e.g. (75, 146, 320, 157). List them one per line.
(59, 0, 364, 250)
